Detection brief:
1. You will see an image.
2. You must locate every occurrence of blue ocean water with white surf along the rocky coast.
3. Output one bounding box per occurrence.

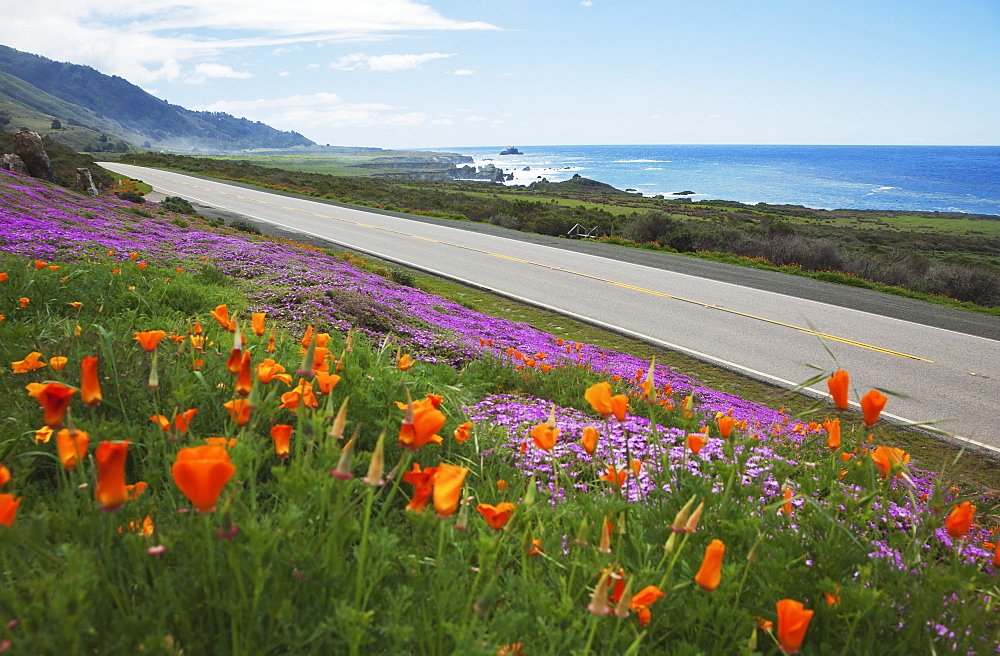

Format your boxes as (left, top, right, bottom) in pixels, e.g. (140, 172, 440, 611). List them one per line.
(440, 145, 1000, 215)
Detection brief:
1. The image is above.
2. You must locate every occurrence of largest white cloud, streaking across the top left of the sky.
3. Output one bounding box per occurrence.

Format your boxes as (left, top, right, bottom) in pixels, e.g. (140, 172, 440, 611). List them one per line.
(2, 0, 498, 85)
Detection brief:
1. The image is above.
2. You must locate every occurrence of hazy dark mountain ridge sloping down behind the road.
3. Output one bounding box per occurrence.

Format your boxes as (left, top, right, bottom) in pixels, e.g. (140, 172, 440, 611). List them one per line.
(0, 45, 315, 153)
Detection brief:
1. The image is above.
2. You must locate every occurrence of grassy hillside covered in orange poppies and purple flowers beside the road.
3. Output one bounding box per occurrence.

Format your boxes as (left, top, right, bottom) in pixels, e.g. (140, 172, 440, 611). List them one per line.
(0, 172, 1000, 656)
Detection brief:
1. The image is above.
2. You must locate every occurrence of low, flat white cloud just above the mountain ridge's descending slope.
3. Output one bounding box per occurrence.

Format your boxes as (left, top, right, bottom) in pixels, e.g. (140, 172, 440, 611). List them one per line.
(197, 92, 429, 129)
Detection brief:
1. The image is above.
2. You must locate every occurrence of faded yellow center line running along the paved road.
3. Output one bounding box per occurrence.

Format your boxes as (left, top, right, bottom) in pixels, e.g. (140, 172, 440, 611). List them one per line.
(160, 172, 934, 363)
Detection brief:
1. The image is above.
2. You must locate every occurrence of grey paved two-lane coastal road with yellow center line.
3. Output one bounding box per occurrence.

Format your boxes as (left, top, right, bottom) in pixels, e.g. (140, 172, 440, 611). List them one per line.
(103, 164, 1000, 452)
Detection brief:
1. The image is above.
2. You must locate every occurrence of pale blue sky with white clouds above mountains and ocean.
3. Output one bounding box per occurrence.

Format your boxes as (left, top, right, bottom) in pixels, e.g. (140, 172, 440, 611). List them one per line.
(0, 0, 1000, 148)
